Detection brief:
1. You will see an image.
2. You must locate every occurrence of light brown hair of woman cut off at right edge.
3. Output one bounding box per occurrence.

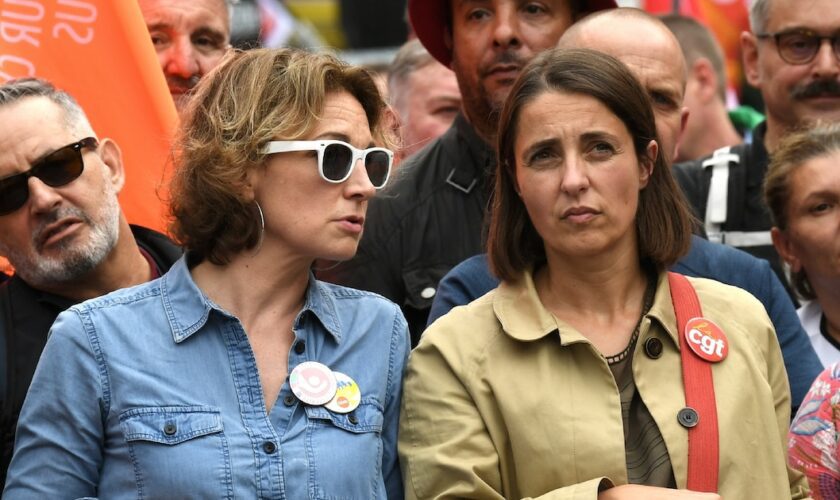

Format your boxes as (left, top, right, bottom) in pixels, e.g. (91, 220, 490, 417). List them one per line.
(764, 124, 840, 300)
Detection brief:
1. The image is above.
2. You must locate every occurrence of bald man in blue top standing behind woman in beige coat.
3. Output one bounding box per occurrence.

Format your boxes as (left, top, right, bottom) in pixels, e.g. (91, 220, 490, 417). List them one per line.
(429, 8, 821, 412)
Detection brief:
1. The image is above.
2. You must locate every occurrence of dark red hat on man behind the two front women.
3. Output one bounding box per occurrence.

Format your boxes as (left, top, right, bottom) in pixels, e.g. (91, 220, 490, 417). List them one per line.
(408, 0, 617, 68)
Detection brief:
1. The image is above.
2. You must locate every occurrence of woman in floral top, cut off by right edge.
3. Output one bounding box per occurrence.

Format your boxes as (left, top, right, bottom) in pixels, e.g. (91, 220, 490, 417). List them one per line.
(764, 123, 840, 500)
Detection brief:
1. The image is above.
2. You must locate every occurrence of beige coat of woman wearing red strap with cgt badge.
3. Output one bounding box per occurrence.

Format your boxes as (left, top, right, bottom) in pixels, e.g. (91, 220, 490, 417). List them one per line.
(399, 273, 808, 500)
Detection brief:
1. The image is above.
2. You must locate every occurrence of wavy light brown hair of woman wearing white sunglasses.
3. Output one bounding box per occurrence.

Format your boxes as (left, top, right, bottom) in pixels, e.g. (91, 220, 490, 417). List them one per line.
(170, 49, 387, 265)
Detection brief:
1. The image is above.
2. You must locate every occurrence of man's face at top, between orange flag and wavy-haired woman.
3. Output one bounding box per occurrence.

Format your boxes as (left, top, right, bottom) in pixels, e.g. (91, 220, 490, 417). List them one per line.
(139, 0, 230, 113)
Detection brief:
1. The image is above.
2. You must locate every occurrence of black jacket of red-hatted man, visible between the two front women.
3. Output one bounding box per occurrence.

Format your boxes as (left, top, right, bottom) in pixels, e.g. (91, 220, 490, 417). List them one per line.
(318, 115, 495, 346)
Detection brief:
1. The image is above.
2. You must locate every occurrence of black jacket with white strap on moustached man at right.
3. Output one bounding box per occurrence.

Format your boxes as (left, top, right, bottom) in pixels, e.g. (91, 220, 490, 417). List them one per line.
(674, 123, 789, 290)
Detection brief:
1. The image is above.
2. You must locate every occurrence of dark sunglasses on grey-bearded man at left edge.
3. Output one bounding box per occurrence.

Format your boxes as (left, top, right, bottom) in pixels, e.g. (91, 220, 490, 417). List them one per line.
(0, 137, 99, 215)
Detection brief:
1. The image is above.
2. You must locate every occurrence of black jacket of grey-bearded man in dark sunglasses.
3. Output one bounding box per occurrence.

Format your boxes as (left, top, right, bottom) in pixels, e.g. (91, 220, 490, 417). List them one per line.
(0, 226, 181, 491)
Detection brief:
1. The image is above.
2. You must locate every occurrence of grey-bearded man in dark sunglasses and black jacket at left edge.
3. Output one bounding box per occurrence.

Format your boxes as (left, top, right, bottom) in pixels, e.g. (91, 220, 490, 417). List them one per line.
(0, 79, 181, 484)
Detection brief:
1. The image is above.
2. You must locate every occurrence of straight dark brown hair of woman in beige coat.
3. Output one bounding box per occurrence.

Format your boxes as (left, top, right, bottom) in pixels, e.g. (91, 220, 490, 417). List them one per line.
(488, 49, 693, 281)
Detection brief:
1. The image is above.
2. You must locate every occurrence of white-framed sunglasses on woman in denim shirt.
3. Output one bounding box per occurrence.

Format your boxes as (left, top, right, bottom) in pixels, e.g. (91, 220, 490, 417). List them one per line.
(262, 141, 394, 189)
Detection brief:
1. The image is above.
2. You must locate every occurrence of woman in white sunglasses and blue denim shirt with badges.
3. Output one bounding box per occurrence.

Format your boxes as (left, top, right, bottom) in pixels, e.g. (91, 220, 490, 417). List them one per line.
(4, 50, 409, 498)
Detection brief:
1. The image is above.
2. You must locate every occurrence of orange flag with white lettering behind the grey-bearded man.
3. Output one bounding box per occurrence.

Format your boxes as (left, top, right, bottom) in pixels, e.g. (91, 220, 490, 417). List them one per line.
(0, 0, 178, 234)
